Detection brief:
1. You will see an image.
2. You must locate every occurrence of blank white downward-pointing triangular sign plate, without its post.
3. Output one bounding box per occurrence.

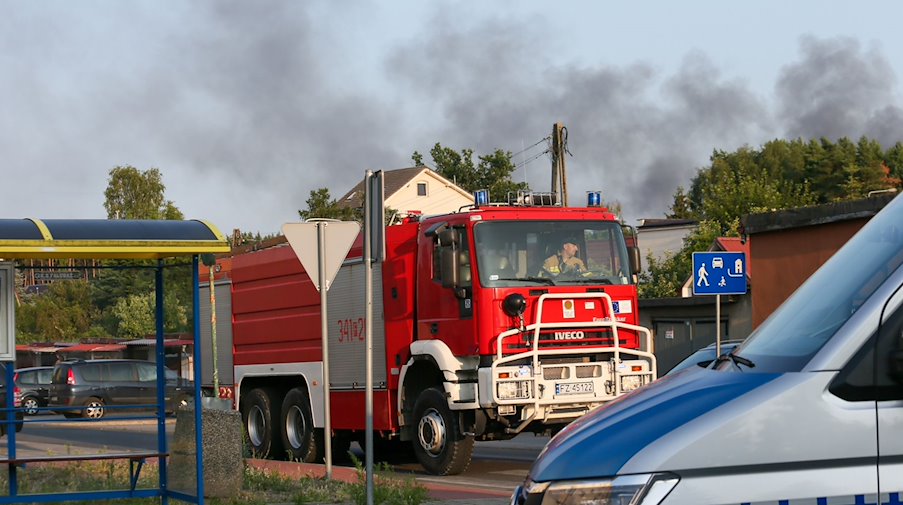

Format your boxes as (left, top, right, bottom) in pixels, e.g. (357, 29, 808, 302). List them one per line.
(282, 221, 361, 291)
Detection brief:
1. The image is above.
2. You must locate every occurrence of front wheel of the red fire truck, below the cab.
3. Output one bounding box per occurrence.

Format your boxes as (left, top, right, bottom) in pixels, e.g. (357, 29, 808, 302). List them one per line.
(413, 388, 473, 475)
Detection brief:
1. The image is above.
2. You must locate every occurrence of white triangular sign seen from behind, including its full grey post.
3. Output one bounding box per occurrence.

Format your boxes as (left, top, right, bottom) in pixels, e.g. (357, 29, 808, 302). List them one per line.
(282, 219, 361, 479)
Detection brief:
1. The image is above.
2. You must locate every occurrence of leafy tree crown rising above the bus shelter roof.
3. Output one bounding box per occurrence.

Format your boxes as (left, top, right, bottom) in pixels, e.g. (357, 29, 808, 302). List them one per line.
(104, 166, 184, 220)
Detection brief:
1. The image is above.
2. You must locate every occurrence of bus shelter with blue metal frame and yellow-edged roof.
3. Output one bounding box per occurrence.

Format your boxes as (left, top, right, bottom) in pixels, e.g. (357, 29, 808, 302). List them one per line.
(0, 219, 229, 504)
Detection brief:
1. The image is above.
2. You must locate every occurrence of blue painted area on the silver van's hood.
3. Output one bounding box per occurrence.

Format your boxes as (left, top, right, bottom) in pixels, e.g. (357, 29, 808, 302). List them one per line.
(530, 370, 780, 482)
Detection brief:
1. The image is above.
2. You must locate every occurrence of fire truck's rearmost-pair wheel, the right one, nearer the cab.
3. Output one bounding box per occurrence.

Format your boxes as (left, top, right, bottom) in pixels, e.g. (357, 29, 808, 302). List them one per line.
(282, 388, 324, 463)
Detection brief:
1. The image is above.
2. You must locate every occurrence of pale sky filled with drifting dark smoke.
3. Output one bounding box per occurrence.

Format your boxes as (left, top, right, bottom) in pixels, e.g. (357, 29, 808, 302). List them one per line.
(0, 0, 903, 233)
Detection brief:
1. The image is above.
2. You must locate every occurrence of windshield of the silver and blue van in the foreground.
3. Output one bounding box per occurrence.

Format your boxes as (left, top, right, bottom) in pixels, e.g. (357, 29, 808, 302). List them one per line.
(737, 198, 903, 373)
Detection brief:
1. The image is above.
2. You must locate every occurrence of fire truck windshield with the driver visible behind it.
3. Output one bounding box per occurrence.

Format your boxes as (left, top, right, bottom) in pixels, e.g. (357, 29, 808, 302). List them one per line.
(474, 221, 631, 287)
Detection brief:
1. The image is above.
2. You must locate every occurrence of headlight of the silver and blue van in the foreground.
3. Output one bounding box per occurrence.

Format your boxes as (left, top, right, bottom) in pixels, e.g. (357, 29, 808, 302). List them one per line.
(512, 473, 680, 505)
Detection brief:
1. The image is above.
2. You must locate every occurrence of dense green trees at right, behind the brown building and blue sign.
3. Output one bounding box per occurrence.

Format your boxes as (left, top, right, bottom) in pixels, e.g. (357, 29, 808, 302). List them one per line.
(640, 137, 903, 297)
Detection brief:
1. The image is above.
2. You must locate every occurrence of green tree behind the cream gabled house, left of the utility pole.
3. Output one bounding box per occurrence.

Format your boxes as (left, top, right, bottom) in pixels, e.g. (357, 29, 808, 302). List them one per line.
(411, 142, 530, 201)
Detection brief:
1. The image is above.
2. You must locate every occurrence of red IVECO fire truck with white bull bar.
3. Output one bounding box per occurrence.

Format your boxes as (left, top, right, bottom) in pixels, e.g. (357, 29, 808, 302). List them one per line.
(202, 193, 656, 475)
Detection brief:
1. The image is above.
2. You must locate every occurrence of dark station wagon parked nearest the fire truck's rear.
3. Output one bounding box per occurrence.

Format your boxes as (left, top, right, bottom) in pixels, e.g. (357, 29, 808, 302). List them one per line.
(49, 359, 193, 419)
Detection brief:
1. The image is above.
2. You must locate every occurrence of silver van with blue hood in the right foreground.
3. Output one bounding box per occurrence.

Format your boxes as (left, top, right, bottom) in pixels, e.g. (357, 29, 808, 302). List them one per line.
(512, 194, 903, 505)
